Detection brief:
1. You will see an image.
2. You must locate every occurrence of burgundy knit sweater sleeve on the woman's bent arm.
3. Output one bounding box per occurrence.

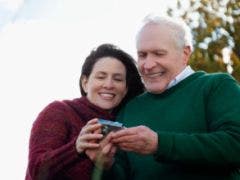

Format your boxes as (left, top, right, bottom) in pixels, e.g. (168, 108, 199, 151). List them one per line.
(26, 102, 90, 180)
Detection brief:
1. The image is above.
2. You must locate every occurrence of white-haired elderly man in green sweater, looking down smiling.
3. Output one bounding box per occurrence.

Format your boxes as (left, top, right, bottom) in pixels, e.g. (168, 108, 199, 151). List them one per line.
(101, 17, 240, 180)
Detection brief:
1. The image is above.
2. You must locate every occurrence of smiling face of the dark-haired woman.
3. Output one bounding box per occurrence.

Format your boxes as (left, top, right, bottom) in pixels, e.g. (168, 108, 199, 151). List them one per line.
(81, 57, 127, 110)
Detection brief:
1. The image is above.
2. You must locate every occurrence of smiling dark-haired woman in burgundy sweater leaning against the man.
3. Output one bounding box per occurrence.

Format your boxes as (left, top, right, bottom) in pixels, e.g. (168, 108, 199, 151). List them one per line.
(26, 44, 143, 180)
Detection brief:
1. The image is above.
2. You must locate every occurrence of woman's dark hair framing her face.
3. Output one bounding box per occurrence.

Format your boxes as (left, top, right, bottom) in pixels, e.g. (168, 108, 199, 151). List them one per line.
(79, 44, 144, 112)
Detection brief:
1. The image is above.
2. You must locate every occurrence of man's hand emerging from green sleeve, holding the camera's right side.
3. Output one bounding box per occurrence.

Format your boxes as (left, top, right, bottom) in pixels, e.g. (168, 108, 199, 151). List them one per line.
(111, 126, 158, 154)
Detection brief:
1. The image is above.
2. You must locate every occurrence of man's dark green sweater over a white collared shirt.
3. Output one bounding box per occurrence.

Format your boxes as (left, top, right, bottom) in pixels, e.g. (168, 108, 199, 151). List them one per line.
(105, 71, 240, 180)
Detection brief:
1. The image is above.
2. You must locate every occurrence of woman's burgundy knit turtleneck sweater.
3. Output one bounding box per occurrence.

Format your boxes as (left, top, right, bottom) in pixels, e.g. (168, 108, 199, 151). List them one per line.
(26, 97, 113, 180)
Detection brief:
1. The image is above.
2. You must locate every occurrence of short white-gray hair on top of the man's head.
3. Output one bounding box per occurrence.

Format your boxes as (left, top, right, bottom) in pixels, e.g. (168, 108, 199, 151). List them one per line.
(136, 14, 193, 51)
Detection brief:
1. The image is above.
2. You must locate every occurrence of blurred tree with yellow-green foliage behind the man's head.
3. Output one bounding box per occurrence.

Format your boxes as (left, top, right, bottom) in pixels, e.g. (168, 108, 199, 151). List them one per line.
(167, 0, 240, 82)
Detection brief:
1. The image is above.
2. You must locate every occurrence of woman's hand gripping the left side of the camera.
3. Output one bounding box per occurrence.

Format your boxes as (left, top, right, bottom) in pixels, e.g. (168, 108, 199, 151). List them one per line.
(75, 118, 103, 154)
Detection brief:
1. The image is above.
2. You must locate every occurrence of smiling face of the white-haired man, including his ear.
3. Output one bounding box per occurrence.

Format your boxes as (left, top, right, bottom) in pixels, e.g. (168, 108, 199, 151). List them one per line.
(137, 24, 190, 94)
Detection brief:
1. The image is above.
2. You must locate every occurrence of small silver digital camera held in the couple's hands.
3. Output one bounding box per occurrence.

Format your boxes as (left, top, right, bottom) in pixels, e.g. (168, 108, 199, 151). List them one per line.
(98, 119, 123, 136)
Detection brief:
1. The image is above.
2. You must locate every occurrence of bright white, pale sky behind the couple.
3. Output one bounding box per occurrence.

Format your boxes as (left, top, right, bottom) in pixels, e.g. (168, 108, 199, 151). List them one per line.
(0, 0, 176, 180)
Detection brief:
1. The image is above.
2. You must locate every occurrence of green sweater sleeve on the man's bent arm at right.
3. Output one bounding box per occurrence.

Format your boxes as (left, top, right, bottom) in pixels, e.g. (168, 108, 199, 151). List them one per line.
(154, 76, 240, 167)
